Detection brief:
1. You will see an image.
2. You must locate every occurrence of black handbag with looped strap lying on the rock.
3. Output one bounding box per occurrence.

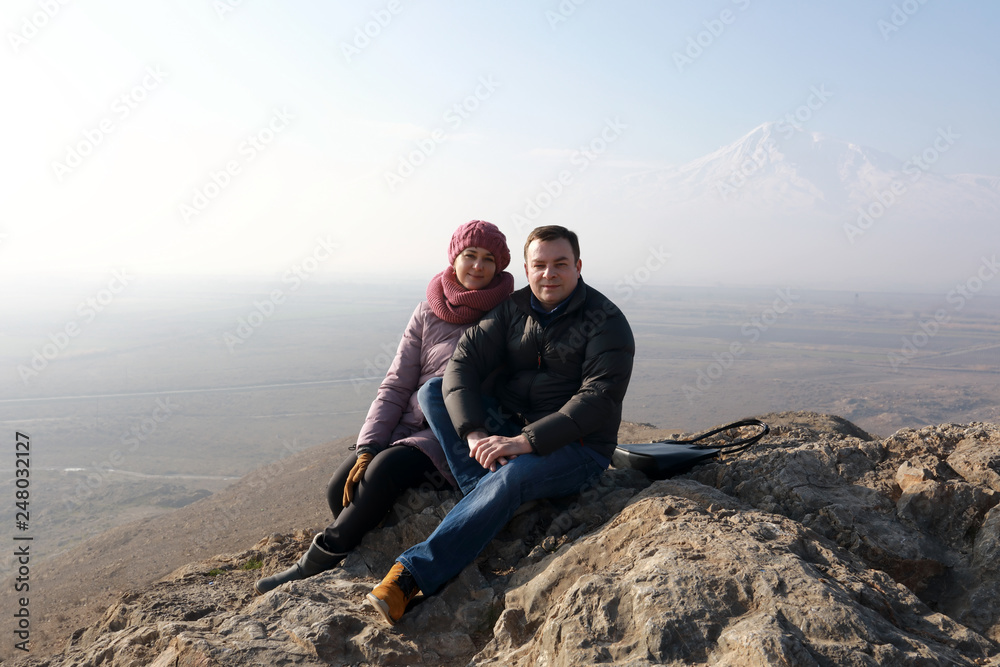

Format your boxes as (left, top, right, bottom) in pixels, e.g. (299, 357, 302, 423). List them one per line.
(611, 419, 771, 480)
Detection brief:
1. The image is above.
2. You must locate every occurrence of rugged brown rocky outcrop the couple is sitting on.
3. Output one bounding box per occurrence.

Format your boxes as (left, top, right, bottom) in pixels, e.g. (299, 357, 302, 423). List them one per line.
(11, 413, 1000, 667)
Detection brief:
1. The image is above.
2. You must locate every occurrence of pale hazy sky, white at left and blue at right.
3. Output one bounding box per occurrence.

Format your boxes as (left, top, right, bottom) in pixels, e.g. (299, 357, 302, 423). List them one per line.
(0, 0, 1000, 291)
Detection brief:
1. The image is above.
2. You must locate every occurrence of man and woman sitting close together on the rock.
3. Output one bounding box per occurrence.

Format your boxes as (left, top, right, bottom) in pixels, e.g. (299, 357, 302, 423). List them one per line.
(254, 220, 635, 624)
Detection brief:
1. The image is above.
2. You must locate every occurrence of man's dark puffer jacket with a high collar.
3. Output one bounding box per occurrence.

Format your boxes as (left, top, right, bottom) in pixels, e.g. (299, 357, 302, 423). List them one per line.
(442, 279, 635, 459)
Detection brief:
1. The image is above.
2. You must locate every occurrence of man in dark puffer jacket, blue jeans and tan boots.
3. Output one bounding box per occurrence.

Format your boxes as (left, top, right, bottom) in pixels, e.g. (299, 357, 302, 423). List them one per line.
(368, 226, 635, 624)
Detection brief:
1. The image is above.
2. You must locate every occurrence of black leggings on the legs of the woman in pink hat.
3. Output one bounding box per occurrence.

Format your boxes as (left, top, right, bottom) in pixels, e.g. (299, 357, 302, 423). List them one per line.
(323, 445, 449, 554)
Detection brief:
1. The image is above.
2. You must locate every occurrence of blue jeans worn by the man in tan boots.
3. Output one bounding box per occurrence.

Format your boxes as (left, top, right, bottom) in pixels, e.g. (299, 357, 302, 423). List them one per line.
(396, 379, 604, 594)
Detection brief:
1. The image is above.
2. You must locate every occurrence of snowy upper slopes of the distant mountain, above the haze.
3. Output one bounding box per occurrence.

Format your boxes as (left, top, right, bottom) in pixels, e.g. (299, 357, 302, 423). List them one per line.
(628, 123, 1000, 216)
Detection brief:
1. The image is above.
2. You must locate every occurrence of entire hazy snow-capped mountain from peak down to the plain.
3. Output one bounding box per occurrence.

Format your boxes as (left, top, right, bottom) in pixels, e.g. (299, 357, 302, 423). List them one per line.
(609, 123, 1000, 291)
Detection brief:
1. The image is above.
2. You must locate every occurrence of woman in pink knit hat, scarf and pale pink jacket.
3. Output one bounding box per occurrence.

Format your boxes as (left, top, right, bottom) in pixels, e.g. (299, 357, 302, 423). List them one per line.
(254, 220, 514, 594)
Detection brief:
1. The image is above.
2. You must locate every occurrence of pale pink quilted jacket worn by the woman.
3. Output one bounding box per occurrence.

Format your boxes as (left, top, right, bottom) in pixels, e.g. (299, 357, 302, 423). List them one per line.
(358, 301, 471, 486)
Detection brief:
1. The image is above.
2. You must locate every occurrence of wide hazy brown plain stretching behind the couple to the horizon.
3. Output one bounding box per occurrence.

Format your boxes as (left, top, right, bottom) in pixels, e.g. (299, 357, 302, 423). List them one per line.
(0, 280, 1000, 578)
